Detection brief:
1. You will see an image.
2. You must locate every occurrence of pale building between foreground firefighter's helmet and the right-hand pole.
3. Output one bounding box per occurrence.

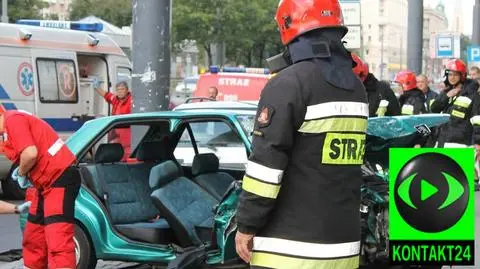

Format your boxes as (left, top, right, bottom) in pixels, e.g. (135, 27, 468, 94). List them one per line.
(361, 0, 408, 80)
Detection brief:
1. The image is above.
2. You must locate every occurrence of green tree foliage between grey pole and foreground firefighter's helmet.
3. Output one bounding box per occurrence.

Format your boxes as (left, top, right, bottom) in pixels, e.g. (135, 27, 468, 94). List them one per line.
(172, 0, 282, 67)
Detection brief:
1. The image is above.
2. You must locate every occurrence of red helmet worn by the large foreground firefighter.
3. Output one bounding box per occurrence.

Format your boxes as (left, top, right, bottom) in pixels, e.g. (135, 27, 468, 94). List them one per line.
(275, 0, 348, 45)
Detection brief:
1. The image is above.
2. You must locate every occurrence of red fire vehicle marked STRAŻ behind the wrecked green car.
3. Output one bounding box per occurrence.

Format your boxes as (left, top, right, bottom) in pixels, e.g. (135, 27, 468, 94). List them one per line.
(193, 66, 273, 102)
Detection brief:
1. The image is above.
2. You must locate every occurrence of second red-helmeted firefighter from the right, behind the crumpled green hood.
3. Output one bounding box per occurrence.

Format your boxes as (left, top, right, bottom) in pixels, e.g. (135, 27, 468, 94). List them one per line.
(394, 71, 427, 115)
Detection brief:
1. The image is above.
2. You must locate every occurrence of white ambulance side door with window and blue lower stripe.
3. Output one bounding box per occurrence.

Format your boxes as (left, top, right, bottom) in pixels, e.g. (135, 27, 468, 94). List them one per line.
(32, 49, 85, 138)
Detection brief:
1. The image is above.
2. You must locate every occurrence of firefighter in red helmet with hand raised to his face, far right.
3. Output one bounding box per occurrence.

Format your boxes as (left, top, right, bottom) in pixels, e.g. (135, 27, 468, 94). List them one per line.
(430, 59, 480, 190)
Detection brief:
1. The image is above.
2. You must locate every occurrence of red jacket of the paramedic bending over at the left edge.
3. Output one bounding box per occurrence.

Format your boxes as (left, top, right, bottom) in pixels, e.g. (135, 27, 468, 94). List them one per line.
(3, 110, 75, 188)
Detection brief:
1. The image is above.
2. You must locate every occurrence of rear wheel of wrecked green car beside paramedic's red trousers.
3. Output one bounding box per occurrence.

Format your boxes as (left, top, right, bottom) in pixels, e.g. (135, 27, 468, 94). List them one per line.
(73, 224, 97, 269)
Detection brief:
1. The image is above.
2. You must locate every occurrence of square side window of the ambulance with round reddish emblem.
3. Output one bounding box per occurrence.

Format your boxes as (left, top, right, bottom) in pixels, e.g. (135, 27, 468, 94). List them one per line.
(37, 59, 78, 103)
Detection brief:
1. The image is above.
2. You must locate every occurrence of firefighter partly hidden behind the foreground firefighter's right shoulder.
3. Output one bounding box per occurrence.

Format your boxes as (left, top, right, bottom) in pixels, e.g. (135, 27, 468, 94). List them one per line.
(352, 53, 400, 117)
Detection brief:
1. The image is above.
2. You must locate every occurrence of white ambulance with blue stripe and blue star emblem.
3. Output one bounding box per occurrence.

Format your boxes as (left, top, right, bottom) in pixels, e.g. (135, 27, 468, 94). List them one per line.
(0, 20, 131, 199)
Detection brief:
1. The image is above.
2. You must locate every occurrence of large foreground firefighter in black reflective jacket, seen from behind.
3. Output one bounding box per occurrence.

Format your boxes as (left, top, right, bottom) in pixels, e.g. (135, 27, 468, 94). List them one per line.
(235, 0, 368, 269)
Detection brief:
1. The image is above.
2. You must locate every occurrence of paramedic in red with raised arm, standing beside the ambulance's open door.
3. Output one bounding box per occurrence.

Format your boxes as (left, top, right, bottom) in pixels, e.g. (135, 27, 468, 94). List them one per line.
(93, 80, 132, 160)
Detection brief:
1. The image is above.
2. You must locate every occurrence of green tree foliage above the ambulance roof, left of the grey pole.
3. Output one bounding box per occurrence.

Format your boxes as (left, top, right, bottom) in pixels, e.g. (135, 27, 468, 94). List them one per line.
(70, 0, 132, 27)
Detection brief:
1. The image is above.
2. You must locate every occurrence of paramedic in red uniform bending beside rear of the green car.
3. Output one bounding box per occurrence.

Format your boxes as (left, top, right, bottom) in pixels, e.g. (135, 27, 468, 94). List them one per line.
(0, 110, 80, 269)
